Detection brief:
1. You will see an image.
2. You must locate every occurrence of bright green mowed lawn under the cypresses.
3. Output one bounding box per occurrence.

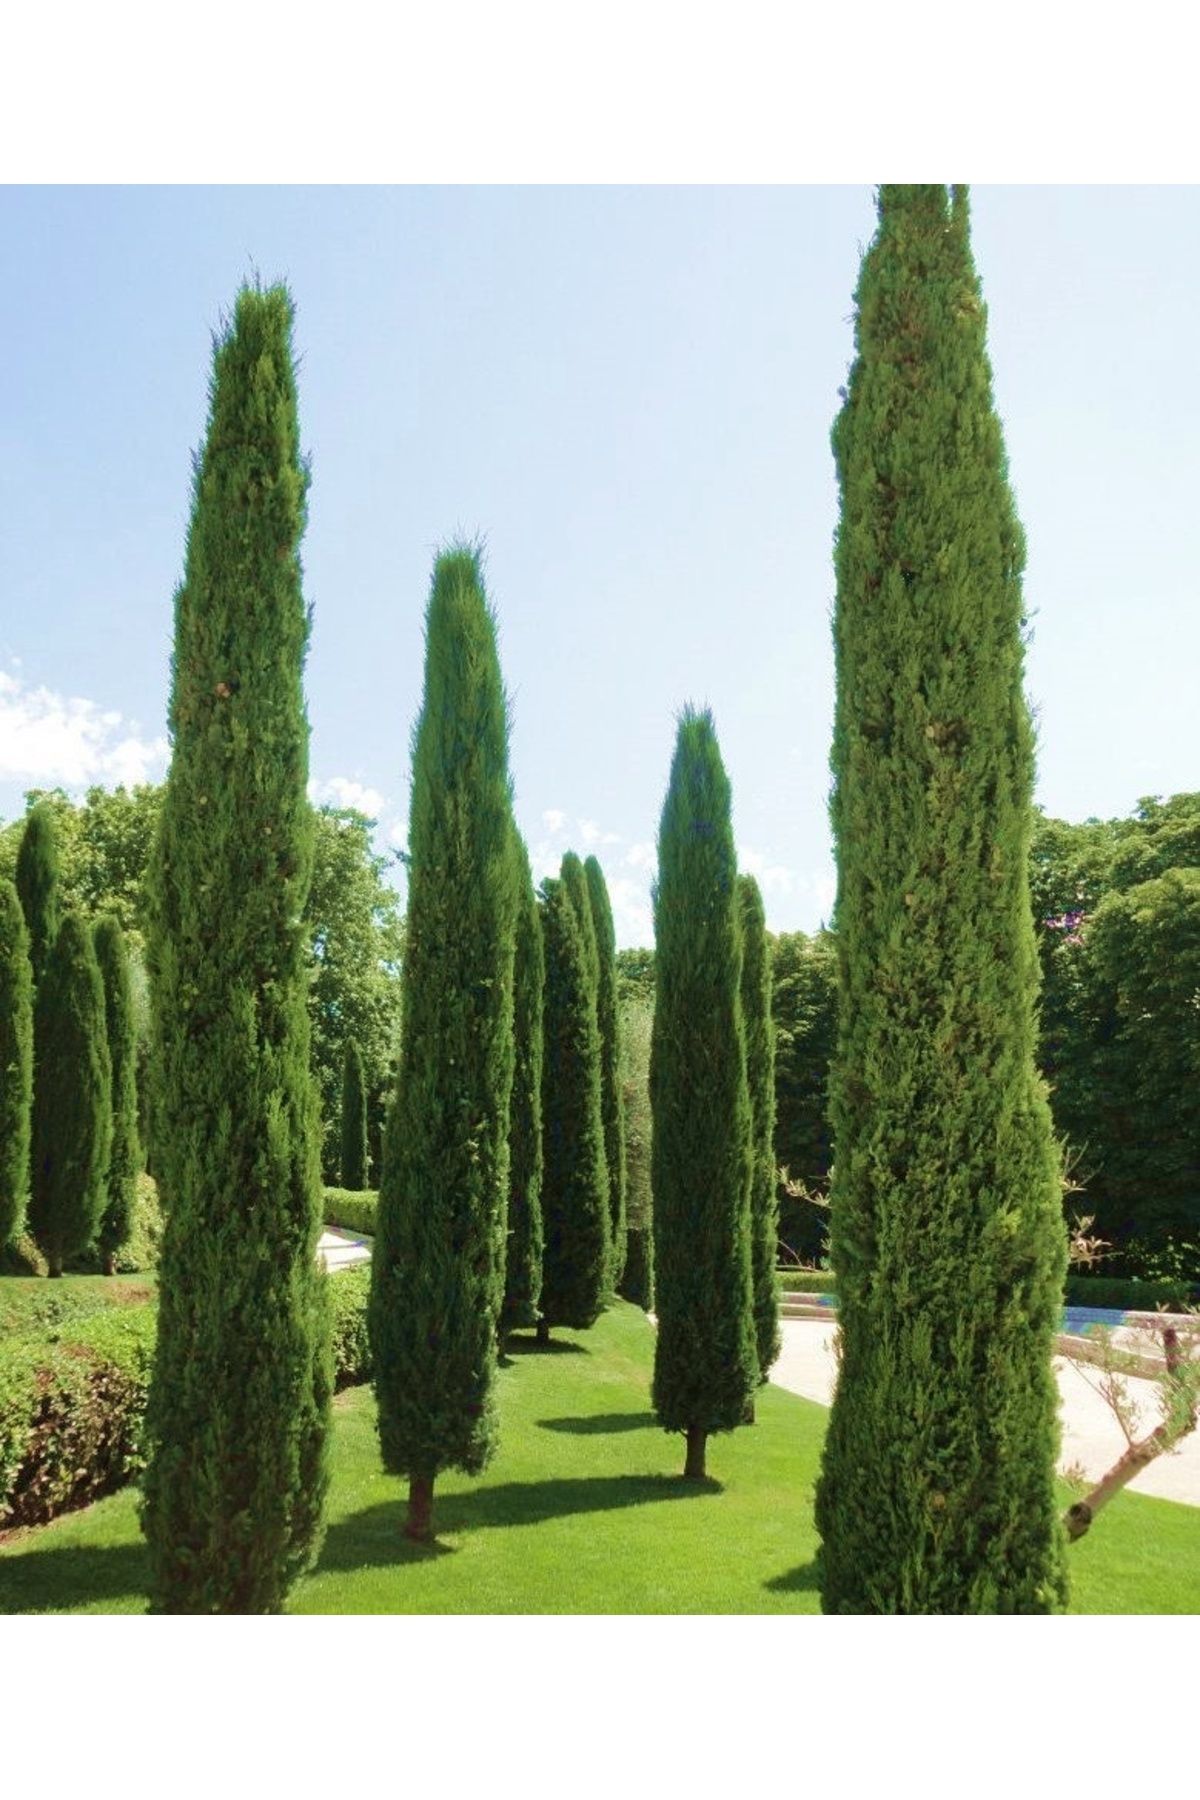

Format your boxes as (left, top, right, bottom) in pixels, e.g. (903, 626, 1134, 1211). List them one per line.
(0, 1303, 1200, 1613)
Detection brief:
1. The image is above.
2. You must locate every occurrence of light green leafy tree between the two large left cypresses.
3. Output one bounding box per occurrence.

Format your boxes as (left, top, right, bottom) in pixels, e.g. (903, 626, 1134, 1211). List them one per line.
(304, 806, 405, 1184)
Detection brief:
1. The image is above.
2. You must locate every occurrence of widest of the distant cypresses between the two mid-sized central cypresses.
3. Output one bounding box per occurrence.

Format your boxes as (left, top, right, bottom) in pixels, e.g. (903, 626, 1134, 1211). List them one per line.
(538, 857, 610, 1341)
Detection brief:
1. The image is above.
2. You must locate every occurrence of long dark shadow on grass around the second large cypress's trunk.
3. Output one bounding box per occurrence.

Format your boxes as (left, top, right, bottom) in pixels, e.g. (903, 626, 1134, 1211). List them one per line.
(313, 1474, 721, 1575)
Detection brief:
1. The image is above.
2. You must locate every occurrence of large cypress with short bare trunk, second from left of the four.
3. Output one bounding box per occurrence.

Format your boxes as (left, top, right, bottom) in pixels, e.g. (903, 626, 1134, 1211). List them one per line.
(369, 547, 516, 1539)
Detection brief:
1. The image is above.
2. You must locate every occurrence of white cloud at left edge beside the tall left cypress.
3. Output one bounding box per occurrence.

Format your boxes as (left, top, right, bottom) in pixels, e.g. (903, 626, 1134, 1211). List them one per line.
(0, 670, 169, 788)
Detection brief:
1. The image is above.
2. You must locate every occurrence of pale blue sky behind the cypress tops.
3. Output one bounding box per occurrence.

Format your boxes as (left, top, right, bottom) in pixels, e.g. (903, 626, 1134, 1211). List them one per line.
(0, 187, 1200, 943)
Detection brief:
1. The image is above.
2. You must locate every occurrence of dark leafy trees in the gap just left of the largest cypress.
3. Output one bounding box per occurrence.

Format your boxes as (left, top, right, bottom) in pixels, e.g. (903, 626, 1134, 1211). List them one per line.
(772, 931, 837, 1262)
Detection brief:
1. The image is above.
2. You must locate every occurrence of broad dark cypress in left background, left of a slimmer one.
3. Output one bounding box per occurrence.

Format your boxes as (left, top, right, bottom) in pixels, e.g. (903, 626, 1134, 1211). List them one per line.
(29, 913, 113, 1276)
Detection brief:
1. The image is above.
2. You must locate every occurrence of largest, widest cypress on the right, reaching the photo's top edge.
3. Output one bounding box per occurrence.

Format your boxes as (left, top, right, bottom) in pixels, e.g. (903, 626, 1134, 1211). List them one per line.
(817, 187, 1065, 1613)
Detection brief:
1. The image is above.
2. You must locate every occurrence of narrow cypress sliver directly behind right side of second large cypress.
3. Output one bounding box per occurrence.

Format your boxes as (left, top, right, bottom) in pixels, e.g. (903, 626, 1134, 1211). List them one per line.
(500, 832, 545, 1343)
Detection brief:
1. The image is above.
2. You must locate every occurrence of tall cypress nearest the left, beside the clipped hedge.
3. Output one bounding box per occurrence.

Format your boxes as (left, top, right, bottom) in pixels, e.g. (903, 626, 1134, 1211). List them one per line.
(142, 286, 331, 1613)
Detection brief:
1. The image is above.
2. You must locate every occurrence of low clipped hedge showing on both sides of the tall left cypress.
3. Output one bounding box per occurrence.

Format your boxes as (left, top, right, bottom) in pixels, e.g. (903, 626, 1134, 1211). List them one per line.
(0, 1264, 371, 1530)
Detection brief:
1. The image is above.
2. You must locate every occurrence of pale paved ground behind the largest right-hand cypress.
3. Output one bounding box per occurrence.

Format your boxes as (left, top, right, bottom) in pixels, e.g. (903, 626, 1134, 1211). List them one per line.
(770, 1319, 1200, 1507)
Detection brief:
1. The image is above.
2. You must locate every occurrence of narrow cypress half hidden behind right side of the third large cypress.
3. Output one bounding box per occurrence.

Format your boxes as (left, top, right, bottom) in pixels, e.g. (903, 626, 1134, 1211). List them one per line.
(738, 875, 781, 1381)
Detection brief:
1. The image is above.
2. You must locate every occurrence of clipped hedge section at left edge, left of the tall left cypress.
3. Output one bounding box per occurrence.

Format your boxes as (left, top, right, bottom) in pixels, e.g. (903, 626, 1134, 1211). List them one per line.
(0, 1305, 155, 1528)
